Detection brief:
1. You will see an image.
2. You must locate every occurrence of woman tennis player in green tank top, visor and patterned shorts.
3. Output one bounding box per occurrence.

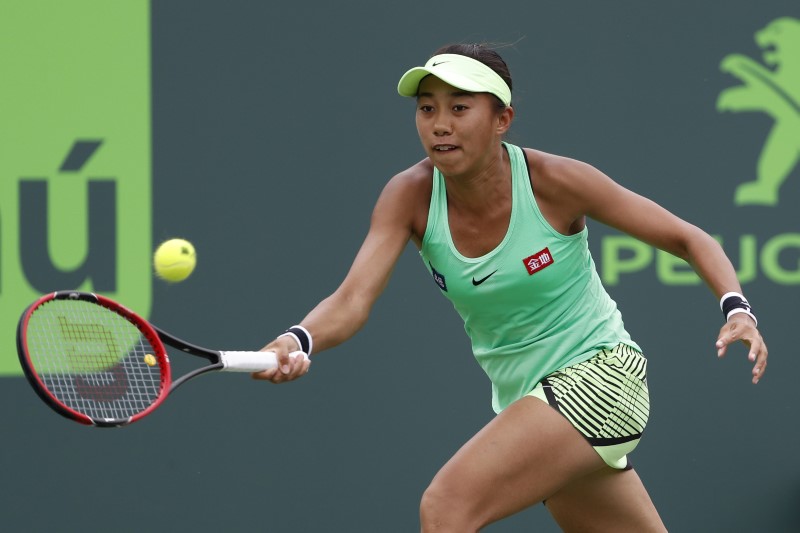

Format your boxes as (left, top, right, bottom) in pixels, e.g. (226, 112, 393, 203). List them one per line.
(254, 45, 767, 533)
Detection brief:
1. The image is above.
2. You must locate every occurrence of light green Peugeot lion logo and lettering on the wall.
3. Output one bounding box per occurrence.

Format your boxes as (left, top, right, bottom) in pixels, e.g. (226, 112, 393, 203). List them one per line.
(600, 17, 800, 286)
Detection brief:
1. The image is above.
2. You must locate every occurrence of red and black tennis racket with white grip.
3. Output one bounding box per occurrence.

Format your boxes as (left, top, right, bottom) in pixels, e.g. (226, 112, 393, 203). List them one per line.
(17, 291, 306, 427)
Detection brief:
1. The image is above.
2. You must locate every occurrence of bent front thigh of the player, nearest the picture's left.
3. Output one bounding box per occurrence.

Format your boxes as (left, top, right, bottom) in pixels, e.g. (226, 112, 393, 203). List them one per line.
(423, 397, 604, 530)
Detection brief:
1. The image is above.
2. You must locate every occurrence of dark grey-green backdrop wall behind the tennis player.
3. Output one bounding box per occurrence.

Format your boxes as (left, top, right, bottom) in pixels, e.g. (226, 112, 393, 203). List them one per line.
(0, 0, 800, 532)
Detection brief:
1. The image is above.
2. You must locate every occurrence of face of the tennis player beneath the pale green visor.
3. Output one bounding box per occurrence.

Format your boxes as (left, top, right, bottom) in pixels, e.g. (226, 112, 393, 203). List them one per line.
(416, 76, 514, 176)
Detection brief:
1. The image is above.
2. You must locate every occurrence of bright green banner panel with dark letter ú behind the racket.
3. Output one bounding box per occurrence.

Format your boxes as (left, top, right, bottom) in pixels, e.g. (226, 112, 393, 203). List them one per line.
(0, 0, 152, 375)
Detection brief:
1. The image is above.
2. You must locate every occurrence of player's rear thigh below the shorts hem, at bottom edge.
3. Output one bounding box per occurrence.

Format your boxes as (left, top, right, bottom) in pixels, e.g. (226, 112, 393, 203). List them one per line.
(547, 467, 666, 533)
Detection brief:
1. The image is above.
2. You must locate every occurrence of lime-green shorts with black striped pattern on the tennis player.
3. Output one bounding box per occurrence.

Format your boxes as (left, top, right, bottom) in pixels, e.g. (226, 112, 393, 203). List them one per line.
(528, 344, 650, 469)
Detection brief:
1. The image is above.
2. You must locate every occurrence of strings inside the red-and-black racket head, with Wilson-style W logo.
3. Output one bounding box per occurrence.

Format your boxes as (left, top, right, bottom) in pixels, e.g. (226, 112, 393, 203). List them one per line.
(27, 300, 163, 420)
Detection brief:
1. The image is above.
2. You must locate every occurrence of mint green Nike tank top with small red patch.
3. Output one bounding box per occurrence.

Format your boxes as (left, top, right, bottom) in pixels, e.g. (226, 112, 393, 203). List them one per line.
(420, 143, 640, 413)
